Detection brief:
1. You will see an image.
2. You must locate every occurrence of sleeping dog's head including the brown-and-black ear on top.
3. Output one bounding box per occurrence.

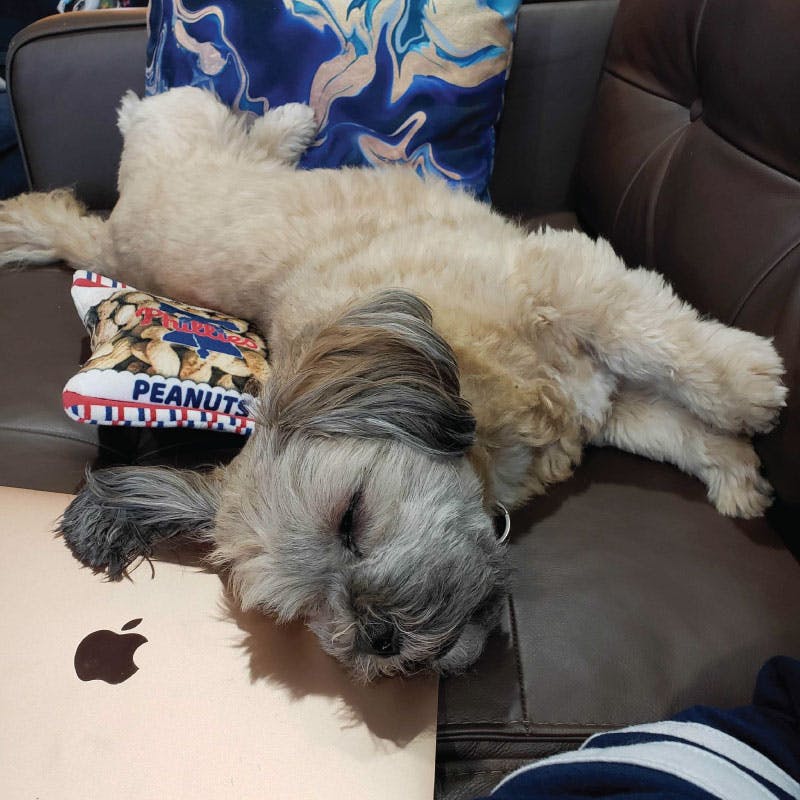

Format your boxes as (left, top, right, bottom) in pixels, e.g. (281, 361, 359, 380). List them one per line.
(62, 291, 507, 680)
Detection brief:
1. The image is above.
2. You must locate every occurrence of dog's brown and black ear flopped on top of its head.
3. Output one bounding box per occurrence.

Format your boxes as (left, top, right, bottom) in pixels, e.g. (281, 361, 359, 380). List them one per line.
(262, 290, 475, 456)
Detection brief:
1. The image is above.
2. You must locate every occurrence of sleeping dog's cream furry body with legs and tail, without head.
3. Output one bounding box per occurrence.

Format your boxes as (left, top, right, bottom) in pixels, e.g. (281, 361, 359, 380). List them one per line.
(0, 89, 785, 516)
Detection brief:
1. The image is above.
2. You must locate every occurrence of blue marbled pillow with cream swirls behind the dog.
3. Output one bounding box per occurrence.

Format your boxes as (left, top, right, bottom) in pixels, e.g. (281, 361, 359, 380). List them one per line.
(147, 0, 520, 197)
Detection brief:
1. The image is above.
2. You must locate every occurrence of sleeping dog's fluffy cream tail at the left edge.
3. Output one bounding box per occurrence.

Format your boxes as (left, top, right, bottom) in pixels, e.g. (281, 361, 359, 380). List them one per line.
(0, 189, 108, 270)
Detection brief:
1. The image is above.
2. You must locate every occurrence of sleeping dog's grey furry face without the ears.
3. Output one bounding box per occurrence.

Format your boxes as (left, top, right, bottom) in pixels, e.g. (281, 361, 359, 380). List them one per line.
(215, 429, 506, 680)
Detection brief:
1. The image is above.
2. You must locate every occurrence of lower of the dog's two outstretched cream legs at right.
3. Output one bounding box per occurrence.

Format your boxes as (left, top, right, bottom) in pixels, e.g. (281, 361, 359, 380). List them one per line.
(591, 385, 772, 518)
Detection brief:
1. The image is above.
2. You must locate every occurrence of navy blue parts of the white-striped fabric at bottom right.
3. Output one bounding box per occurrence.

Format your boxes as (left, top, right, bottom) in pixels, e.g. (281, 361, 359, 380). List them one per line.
(482, 656, 800, 800)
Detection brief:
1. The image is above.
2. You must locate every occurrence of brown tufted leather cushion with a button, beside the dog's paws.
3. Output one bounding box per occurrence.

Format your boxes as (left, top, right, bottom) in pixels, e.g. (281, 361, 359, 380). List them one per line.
(577, 0, 800, 503)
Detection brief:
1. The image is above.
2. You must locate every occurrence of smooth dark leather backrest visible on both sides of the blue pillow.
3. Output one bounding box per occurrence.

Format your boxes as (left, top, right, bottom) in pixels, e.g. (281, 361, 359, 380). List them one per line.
(9, 0, 617, 215)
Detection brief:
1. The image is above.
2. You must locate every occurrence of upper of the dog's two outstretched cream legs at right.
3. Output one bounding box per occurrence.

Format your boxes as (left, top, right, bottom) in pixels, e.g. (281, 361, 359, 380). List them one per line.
(528, 231, 786, 433)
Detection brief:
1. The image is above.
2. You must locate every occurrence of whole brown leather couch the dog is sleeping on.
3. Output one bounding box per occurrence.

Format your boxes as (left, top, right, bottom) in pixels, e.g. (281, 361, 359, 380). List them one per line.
(0, 0, 800, 798)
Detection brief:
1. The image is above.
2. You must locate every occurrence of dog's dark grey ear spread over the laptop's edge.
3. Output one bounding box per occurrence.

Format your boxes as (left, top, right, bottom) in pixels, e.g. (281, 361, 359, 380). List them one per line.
(58, 467, 219, 578)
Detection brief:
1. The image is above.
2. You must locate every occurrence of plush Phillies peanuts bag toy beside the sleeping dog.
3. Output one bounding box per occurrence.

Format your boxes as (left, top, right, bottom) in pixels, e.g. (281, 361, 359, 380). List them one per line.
(63, 270, 269, 434)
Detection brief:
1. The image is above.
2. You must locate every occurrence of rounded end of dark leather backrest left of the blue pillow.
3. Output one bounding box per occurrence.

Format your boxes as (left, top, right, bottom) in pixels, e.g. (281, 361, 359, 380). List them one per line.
(7, 9, 147, 208)
